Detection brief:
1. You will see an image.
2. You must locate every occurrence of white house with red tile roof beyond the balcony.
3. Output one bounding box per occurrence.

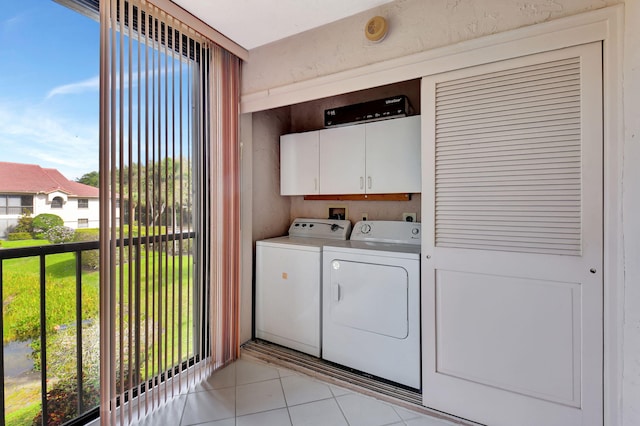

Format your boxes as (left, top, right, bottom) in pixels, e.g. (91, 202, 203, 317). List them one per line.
(0, 161, 100, 238)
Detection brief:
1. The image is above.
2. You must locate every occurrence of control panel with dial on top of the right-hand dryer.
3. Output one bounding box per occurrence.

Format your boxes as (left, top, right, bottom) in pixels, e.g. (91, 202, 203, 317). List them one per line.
(351, 220, 422, 245)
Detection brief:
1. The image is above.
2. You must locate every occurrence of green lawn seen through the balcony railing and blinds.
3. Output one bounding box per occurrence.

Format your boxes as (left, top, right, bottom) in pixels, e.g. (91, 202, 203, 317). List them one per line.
(2, 240, 193, 426)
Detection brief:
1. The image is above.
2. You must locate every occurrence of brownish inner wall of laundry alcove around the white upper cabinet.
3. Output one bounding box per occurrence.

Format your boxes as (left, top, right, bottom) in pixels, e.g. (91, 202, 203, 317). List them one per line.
(252, 80, 420, 230)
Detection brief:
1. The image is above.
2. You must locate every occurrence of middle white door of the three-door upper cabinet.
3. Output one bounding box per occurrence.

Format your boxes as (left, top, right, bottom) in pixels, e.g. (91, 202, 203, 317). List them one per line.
(320, 125, 365, 194)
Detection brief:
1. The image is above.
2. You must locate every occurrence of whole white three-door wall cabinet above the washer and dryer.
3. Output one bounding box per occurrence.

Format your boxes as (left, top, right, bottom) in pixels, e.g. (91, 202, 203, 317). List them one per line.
(280, 115, 422, 195)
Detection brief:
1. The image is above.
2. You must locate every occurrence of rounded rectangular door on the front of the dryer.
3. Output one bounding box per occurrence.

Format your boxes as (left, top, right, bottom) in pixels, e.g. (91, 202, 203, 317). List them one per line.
(329, 259, 409, 339)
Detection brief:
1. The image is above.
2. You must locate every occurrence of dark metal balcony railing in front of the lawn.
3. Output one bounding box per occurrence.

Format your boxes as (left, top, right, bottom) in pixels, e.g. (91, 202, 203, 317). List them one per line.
(0, 232, 195, 425)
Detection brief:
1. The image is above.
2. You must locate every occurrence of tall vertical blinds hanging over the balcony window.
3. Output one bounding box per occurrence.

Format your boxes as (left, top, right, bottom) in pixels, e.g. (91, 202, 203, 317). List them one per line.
(100, 0, 240, 424)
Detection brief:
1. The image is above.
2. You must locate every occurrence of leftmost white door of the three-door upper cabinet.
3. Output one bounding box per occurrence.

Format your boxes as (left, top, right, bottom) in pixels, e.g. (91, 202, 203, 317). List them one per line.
(280, 130, 320, 195)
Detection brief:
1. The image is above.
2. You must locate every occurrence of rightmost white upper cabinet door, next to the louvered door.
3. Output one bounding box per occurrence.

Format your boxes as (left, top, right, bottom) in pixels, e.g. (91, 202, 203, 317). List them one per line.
(366, 115, 422, 194)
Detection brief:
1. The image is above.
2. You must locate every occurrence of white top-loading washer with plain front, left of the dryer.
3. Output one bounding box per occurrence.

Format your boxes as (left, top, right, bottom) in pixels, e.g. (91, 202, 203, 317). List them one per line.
(255, 219, 351, 357)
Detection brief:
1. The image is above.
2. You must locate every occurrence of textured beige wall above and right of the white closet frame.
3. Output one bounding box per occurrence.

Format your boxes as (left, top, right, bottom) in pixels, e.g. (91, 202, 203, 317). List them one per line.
(242, 0, 640, 426)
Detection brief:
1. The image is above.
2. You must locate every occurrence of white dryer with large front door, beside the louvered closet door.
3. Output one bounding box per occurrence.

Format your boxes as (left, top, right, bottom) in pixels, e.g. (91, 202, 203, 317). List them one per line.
(322, 221, 421, 389)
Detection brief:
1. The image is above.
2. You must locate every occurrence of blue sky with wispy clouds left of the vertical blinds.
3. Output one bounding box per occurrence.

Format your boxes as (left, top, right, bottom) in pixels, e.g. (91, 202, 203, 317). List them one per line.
(0, 0, 100, 180)
